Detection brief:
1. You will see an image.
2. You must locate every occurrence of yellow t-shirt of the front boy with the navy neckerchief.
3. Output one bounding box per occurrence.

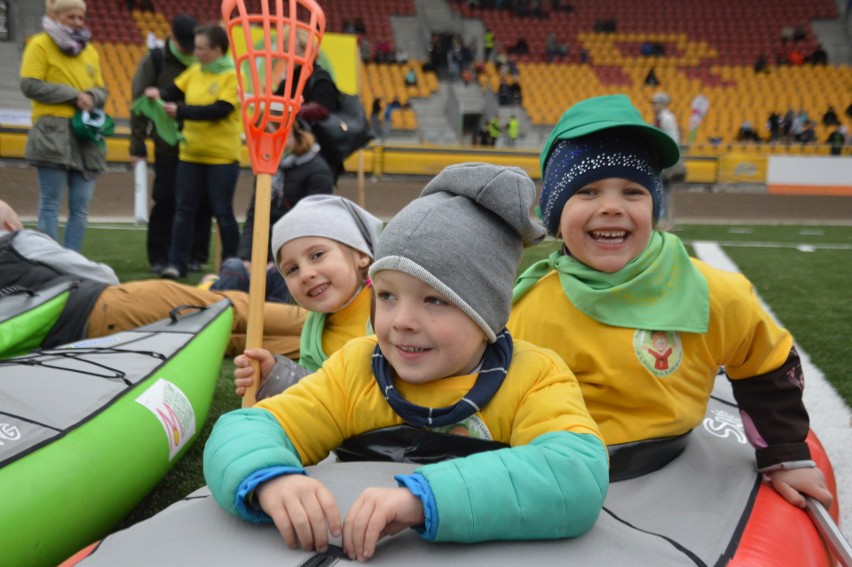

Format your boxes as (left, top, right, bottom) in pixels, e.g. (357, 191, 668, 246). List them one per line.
(256, 336, 601, 465)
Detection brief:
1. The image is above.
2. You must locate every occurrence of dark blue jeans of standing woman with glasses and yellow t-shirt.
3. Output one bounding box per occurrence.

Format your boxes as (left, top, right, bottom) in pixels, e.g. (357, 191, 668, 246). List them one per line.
(169, 161, 240, 274)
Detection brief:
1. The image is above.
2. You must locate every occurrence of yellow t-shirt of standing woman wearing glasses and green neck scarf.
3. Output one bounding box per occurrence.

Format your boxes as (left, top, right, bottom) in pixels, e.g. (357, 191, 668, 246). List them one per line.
(175, 63, 243, 165)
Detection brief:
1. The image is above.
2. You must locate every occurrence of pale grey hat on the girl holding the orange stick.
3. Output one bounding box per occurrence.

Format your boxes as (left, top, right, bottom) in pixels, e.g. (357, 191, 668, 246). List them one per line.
(272, 195, 382, 272)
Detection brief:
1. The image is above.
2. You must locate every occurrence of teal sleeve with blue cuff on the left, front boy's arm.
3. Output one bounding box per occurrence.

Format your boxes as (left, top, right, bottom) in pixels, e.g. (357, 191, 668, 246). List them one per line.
(204, 408, 303, 521)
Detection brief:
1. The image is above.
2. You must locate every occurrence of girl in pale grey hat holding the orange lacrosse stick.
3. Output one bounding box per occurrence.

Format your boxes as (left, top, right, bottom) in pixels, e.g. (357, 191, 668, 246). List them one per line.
(234, 195, 382, 400)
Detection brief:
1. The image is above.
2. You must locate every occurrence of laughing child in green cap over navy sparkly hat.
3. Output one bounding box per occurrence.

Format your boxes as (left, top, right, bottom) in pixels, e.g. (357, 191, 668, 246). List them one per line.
(508, 95, 832, 507)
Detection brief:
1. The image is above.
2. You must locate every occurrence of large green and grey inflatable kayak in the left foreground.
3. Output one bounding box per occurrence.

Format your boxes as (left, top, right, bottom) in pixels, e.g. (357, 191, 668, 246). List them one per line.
(0, 300, 232, 566)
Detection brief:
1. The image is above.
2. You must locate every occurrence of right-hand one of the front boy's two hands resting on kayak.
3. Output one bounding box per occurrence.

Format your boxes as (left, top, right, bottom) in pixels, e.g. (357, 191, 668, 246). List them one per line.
(343, 488, 426, 561)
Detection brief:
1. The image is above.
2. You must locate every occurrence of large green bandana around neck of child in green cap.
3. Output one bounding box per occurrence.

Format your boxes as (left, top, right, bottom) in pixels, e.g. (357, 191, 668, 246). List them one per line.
(512, 232, 710, 333)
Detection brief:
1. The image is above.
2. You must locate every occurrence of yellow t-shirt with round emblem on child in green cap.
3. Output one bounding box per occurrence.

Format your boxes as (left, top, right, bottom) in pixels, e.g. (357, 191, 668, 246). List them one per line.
(508, 260, 793, 445)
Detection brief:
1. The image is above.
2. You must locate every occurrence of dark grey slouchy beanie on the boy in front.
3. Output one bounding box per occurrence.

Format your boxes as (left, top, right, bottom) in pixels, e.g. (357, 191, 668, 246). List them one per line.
(370, 163, 545, 342)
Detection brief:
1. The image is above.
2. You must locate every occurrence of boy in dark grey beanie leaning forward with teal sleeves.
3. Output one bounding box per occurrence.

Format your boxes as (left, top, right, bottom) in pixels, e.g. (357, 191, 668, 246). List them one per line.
(204, 164, 608, 561)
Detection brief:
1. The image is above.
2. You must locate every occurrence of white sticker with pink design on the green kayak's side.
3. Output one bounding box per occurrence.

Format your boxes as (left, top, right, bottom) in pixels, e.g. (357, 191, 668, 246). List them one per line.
(136, 378, 195, 461)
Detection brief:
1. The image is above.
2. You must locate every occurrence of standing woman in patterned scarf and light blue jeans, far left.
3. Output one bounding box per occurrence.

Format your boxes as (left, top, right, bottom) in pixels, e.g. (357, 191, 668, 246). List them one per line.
(21, 0, 107, 251)
